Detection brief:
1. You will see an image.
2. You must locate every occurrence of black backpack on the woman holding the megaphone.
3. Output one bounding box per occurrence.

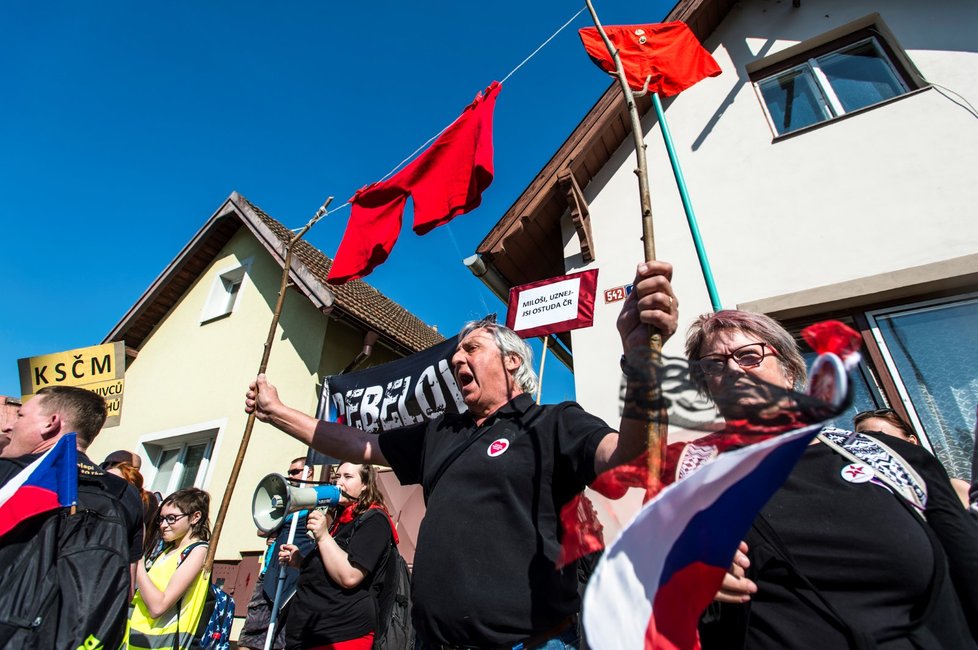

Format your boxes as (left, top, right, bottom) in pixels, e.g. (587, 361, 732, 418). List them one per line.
(355, 510, 414, 650)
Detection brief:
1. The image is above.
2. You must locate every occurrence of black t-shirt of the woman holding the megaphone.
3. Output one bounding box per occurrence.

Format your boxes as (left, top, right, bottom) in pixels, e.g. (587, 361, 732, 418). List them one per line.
(285, 510, 391, 649)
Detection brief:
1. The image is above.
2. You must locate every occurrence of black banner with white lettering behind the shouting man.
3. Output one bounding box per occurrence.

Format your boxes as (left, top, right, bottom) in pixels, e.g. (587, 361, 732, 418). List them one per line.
(307, 336, 466, 465)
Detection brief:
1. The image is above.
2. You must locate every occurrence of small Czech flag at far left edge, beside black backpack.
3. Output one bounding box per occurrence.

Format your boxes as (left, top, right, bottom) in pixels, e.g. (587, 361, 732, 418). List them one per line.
(0, 433, 78, 536)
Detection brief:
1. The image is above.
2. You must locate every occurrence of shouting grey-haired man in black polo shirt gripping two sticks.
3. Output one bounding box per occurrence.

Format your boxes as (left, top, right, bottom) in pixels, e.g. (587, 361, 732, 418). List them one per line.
(246, 262, 678, 650)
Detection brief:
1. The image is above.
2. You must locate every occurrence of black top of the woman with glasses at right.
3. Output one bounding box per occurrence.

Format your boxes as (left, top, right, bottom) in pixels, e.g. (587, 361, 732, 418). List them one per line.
(704, 437, 978, 650)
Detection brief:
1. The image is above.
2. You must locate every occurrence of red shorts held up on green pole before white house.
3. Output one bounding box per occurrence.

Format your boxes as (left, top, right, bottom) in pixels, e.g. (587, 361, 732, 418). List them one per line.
(579, 21, 720, 96)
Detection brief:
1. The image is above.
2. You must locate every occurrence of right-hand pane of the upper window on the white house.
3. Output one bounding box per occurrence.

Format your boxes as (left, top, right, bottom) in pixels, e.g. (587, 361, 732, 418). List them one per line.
(818, 41, 904, 113)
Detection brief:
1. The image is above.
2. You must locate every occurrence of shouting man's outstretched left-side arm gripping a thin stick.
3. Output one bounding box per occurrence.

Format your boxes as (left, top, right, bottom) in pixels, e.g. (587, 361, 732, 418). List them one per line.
(245, 375, 387, 465)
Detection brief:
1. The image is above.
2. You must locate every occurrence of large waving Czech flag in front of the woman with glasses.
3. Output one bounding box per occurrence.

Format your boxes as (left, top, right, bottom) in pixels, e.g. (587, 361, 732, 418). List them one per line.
(584, 425, 821, 650)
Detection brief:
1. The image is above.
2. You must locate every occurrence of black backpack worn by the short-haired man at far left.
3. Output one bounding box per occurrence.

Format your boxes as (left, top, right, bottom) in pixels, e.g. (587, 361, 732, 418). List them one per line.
(0, 468, 130, 650)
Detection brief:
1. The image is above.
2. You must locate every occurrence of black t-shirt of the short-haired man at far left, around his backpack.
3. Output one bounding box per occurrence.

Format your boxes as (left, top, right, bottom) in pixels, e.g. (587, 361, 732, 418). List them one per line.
(0, 452, 143, 563)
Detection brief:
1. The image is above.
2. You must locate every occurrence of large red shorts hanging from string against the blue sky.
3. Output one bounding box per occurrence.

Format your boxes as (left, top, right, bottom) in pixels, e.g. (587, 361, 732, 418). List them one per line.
(328, 81, 500, 284)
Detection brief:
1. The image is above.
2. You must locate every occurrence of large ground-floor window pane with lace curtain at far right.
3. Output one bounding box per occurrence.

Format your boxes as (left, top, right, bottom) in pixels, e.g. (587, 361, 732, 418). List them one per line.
(876, 299, 978, 480)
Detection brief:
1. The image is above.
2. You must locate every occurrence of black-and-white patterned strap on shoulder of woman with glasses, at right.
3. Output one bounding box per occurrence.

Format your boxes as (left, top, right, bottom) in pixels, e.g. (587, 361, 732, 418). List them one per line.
(818, 427, 927, 516)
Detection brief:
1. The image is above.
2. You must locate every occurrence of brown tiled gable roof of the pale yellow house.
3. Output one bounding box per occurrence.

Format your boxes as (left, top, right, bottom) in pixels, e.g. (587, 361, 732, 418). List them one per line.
(105, 192, 444, 355)
